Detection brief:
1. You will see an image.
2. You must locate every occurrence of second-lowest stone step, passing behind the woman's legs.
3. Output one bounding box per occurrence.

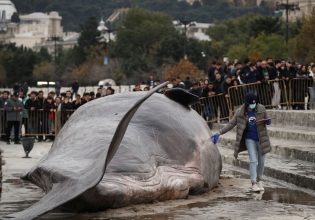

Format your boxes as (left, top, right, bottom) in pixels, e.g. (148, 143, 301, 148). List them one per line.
(220, 131, 315, 163)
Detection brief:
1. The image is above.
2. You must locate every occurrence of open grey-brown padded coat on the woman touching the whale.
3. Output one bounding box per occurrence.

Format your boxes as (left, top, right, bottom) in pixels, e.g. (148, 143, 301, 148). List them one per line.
(220, 104, 271, 158)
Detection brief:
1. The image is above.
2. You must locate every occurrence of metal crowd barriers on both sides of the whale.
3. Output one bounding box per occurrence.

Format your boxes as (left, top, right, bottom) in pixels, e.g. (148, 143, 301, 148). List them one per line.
(0, 78, 315, 137)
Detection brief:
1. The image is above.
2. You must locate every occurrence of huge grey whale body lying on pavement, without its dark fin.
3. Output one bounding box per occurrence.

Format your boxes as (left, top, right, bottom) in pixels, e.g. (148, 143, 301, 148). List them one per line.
(10, 83, 222, 219)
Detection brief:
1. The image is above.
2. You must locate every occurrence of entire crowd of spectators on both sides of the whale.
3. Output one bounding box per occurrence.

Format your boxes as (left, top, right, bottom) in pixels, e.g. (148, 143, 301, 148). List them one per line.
(0, 58, 315, 144)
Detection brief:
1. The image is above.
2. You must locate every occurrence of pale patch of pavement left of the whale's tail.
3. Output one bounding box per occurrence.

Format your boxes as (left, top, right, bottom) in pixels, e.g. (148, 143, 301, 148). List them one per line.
(0, 142, 51, 218)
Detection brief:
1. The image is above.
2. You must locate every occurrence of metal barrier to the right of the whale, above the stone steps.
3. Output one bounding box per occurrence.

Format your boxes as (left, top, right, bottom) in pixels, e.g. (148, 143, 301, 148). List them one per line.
(192, 78, 315, 123)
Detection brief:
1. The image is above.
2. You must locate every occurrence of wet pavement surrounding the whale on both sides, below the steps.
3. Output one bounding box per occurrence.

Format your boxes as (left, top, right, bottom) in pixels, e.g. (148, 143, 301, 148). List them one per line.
(0, 142, 315, 220)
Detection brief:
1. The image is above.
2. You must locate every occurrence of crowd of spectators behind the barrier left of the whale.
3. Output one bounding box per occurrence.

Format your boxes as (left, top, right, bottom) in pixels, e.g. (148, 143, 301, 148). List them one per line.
(0, 86, 115, 144)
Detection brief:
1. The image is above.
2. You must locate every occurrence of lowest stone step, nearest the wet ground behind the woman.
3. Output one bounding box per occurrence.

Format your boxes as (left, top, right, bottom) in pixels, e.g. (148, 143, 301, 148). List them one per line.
(218, 145, 315, 190)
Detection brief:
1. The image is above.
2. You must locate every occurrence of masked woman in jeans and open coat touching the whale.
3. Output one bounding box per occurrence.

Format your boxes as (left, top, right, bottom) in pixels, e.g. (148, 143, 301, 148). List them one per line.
(211, 93, 271, 192)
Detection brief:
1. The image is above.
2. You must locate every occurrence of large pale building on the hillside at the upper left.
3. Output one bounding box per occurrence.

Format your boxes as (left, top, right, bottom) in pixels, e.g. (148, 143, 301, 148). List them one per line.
(0, 0, 78, 51)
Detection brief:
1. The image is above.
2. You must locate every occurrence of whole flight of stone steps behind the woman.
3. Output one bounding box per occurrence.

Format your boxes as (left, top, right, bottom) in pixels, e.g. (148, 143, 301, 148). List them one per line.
(213, 110, 315, 190)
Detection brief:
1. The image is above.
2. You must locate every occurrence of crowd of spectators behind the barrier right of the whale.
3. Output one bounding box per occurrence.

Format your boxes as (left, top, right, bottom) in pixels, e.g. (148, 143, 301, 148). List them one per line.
(168, 58, 315, 97)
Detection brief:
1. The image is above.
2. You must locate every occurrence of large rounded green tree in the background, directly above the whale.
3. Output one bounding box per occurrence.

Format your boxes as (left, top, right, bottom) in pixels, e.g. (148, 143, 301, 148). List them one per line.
(110, 8, 211, 83)
